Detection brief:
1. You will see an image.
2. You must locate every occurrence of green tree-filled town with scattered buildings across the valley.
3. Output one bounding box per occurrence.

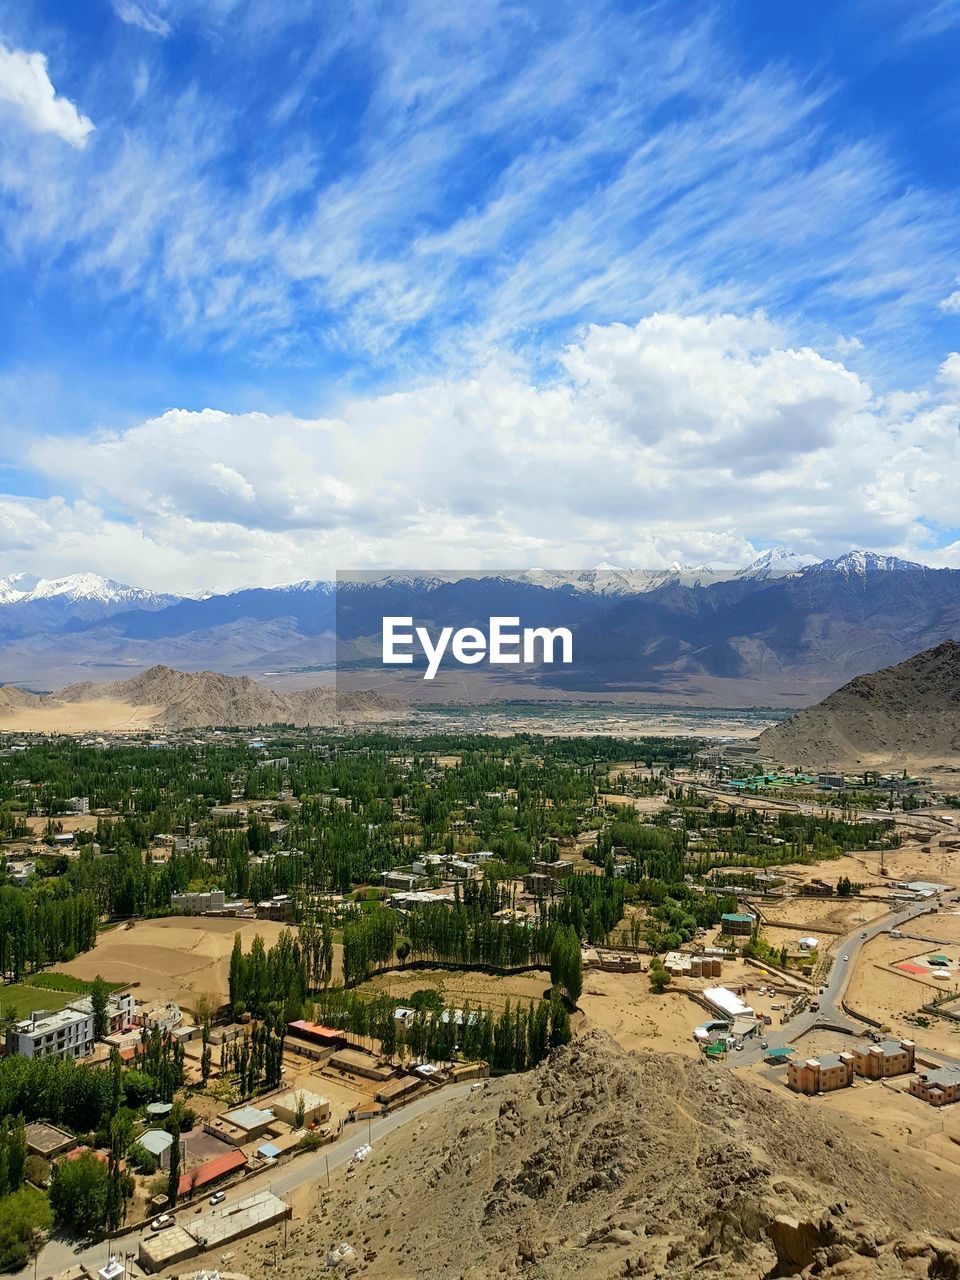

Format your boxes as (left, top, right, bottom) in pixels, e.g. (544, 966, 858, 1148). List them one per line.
(0, 732, 960, 1280)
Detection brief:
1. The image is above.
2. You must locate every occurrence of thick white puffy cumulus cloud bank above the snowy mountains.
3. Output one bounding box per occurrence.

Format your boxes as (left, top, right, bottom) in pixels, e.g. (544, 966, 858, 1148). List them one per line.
(7, 314, 960, 590)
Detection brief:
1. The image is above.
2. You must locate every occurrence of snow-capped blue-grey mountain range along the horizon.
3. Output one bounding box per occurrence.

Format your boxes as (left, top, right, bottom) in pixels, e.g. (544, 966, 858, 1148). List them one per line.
(0, 548, 960, 708)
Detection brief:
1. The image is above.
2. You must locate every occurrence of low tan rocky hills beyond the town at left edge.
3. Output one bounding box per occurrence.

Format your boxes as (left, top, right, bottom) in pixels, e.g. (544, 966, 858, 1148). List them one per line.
(0, 667, 404, 732)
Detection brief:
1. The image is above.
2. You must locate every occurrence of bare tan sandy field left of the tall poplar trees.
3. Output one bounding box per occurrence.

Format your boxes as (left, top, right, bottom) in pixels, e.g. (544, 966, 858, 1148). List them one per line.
(59, 915, 295, 1007)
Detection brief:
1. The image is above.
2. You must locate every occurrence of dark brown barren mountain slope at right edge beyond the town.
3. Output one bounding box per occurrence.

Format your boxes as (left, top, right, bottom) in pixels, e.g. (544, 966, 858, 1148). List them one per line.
(758, 640, 960, 768)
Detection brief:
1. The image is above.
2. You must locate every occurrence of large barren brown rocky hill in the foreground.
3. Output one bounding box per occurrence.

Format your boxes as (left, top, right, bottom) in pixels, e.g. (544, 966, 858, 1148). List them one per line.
(285, 1032, 960, 1280)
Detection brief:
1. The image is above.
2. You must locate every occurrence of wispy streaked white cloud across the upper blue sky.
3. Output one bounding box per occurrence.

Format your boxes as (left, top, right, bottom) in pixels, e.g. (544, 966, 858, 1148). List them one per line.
(0, 0, 957, 370)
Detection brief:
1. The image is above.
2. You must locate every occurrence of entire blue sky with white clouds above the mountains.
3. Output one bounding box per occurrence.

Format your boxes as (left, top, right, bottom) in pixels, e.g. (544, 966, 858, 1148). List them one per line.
(0, 0, 960, 591)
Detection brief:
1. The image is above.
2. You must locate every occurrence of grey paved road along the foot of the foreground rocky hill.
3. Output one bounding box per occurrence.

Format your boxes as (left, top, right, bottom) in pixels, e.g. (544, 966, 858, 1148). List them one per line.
(36, 1084, 472, 1277)
